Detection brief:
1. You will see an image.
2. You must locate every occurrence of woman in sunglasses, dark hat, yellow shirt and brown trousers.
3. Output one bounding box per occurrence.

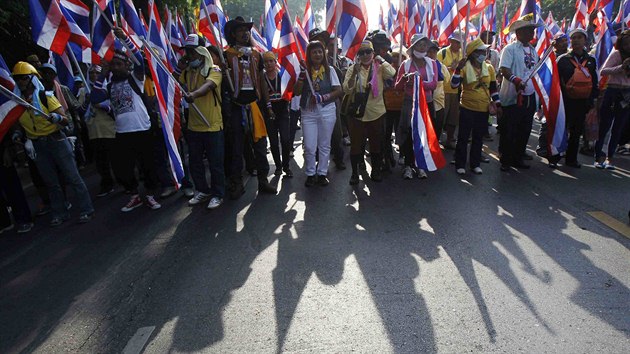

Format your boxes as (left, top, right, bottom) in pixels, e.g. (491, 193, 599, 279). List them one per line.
(343, 41, 396, 185)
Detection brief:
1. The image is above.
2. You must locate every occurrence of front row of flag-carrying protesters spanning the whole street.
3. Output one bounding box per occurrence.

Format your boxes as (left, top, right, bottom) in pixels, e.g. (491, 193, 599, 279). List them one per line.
(0, 13, 630, 233)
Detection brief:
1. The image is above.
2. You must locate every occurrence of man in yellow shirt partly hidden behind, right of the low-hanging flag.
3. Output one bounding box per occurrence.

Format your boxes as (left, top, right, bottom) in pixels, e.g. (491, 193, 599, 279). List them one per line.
(437, 31, 463, 149)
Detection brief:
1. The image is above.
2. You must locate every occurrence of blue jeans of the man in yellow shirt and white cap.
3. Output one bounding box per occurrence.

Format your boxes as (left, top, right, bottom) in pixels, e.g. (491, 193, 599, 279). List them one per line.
(186, 130, 225, 198)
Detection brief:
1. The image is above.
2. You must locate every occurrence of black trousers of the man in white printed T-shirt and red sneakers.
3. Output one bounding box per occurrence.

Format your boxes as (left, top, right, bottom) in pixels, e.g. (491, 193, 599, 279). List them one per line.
(113, 130, 158, 195)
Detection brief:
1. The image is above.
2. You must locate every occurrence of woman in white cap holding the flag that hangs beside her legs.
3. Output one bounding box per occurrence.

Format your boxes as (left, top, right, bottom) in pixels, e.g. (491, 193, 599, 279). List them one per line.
(395, 34, 438, 179)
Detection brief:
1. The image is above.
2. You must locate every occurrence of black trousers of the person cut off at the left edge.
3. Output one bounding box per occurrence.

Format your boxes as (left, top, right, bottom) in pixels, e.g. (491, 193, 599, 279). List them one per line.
(0, 165, 32, 227)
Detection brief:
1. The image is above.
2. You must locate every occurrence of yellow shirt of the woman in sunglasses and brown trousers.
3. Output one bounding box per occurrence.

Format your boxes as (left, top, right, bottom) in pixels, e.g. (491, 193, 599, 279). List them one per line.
(343, 62, 396, 122)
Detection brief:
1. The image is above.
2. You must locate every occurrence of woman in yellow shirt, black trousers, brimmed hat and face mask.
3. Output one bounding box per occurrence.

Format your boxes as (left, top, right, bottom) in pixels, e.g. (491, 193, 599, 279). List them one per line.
(451, 38, 500, 175)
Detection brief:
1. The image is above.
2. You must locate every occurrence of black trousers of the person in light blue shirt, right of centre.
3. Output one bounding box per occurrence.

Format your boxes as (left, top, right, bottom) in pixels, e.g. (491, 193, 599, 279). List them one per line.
(499, 95, 536, 166)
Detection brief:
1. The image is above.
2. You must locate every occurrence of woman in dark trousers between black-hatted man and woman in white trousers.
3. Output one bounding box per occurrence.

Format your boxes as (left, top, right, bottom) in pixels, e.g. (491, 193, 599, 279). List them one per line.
(260, 51, 293, 177)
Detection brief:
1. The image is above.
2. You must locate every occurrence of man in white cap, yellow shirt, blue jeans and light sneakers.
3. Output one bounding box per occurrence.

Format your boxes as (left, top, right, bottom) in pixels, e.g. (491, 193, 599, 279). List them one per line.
(179, 34, 225, 209)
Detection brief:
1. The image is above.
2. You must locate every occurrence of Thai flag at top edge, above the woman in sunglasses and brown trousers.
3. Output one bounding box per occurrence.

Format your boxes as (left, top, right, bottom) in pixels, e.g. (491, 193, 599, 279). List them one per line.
(337, 0, 368, 60)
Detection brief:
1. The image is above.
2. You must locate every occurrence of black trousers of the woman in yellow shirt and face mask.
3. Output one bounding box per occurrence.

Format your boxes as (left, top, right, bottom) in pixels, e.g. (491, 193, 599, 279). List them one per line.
(455, 107, 488, 168)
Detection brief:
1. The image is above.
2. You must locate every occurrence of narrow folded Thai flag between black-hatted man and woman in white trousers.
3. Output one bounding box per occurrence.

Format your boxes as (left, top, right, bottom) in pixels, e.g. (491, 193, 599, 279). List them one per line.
(274, 3, 300, 101)
